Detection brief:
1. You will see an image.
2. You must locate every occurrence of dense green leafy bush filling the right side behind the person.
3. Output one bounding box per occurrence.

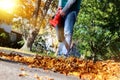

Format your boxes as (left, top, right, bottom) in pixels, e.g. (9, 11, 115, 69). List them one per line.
(73, 0, 120, 59)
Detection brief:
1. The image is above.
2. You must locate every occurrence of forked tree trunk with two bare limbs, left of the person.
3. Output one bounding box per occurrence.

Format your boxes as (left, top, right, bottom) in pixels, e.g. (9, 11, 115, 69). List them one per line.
(21, 0, 52, 51)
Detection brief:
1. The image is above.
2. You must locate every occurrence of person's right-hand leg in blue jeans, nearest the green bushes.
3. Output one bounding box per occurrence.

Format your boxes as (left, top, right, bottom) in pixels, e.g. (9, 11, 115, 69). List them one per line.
(64, 11, 77, 54)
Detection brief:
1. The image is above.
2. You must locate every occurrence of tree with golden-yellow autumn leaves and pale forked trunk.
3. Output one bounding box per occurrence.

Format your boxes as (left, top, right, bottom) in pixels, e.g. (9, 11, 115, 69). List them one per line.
(0, 0, 57, 50)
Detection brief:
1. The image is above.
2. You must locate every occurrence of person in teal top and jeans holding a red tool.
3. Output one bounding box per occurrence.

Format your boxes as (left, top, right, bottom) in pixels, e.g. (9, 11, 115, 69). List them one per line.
(50, 0, 81, 56)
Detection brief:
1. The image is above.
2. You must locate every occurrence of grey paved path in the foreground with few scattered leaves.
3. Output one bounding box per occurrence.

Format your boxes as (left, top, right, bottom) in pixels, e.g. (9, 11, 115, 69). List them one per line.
(0, 59, 79, 80)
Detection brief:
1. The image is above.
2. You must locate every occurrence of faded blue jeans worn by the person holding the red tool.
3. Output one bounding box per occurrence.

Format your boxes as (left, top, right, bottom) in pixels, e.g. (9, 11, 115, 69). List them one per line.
(56, 11, 78, 55)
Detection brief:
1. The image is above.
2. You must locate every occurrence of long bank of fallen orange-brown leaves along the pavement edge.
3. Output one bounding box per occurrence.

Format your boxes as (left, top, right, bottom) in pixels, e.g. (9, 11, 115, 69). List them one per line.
(0, 52, 120, 80)
